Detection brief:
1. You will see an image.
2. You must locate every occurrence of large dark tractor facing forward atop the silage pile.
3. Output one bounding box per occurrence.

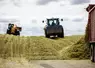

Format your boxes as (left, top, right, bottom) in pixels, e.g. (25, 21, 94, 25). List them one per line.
(43, 18, 64, 38)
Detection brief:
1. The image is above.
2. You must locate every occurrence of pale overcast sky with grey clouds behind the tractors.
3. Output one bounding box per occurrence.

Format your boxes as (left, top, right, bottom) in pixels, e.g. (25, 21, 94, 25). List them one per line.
(0, 0, 95, 36)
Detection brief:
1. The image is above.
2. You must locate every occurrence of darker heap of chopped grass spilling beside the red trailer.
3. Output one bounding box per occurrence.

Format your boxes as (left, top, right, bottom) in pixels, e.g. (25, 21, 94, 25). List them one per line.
(62, 36, 90, 59)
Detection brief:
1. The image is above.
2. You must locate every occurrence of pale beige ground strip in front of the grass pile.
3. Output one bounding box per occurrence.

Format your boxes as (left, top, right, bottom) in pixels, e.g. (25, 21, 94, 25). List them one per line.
(0, 58, 95, 68)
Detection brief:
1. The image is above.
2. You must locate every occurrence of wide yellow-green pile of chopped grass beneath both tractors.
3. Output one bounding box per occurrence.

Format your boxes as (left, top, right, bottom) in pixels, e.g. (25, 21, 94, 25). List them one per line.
(0, 35, 89, 60)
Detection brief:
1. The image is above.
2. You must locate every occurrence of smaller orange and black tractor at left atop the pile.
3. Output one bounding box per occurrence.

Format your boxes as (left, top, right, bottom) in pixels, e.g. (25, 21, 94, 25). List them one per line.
(6, 23, 22, 35)
